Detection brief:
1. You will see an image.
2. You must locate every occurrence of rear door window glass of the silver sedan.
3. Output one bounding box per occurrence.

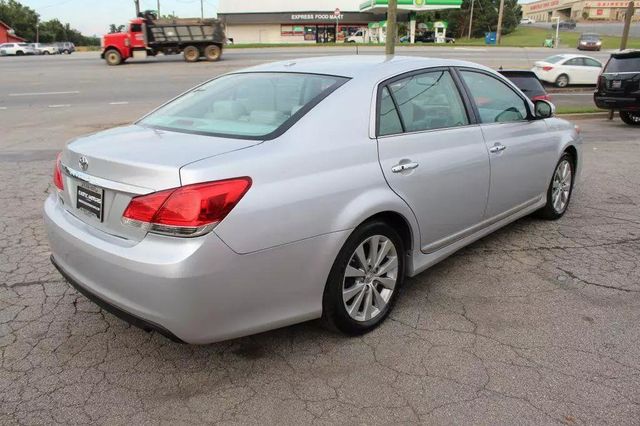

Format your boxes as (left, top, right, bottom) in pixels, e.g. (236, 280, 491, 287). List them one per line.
(388, 70, 469, 132)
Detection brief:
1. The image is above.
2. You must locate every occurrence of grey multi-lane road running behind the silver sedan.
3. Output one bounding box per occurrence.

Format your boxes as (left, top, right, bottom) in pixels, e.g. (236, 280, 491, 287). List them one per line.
(0, 47, 608, 138)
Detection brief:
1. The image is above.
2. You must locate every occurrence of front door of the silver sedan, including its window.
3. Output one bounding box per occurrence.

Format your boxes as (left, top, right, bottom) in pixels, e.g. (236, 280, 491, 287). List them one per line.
(459, 69, 557, 219)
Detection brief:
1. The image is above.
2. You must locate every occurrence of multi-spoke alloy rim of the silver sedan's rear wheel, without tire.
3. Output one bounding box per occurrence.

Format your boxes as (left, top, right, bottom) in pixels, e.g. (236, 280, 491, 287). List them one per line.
(342, 235, 398, 322)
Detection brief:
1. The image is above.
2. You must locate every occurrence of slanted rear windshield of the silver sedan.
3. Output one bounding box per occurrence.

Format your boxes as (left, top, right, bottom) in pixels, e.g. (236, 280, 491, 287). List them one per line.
(138, 73, 347, 139)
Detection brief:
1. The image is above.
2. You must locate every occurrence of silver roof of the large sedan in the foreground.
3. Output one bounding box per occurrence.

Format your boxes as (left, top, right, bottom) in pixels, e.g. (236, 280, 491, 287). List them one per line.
(243, 55, 495, 80)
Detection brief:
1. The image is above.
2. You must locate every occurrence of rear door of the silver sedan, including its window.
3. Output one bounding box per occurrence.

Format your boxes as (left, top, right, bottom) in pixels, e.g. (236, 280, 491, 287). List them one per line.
(377, 68, 489, 252)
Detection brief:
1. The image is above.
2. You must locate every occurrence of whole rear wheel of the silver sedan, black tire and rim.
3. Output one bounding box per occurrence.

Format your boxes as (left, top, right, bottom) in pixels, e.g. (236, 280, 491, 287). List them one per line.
(322, 220, 405, 335)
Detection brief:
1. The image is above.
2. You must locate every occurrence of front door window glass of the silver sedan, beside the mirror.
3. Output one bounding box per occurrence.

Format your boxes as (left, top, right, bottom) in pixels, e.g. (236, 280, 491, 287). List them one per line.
(461, 71, 528, 123)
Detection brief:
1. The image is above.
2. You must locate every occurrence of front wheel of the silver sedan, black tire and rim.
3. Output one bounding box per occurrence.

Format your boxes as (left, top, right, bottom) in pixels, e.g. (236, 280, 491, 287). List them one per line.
(536, 152, 575, 220)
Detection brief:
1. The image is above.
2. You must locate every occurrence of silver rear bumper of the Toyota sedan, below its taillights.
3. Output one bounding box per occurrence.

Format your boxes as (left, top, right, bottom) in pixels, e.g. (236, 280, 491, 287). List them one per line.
(44, 194, 348, 343)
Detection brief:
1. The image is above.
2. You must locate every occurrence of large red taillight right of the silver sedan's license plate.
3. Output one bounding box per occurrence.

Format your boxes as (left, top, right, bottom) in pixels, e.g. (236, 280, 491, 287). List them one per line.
(122, 177, 251, 237)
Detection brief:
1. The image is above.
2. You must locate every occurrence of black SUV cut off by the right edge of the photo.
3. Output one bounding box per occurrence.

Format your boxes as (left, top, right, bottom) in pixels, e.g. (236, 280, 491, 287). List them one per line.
(593, 50, 640, 126)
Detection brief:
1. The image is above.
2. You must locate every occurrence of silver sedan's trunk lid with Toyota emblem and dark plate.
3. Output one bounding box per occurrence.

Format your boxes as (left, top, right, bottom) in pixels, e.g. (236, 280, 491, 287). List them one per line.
(61, 125, 260, 241)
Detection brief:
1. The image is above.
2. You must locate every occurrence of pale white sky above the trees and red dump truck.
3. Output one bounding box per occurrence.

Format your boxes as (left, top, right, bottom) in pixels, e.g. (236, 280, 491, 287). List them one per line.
(18, 0, 218, 36)
